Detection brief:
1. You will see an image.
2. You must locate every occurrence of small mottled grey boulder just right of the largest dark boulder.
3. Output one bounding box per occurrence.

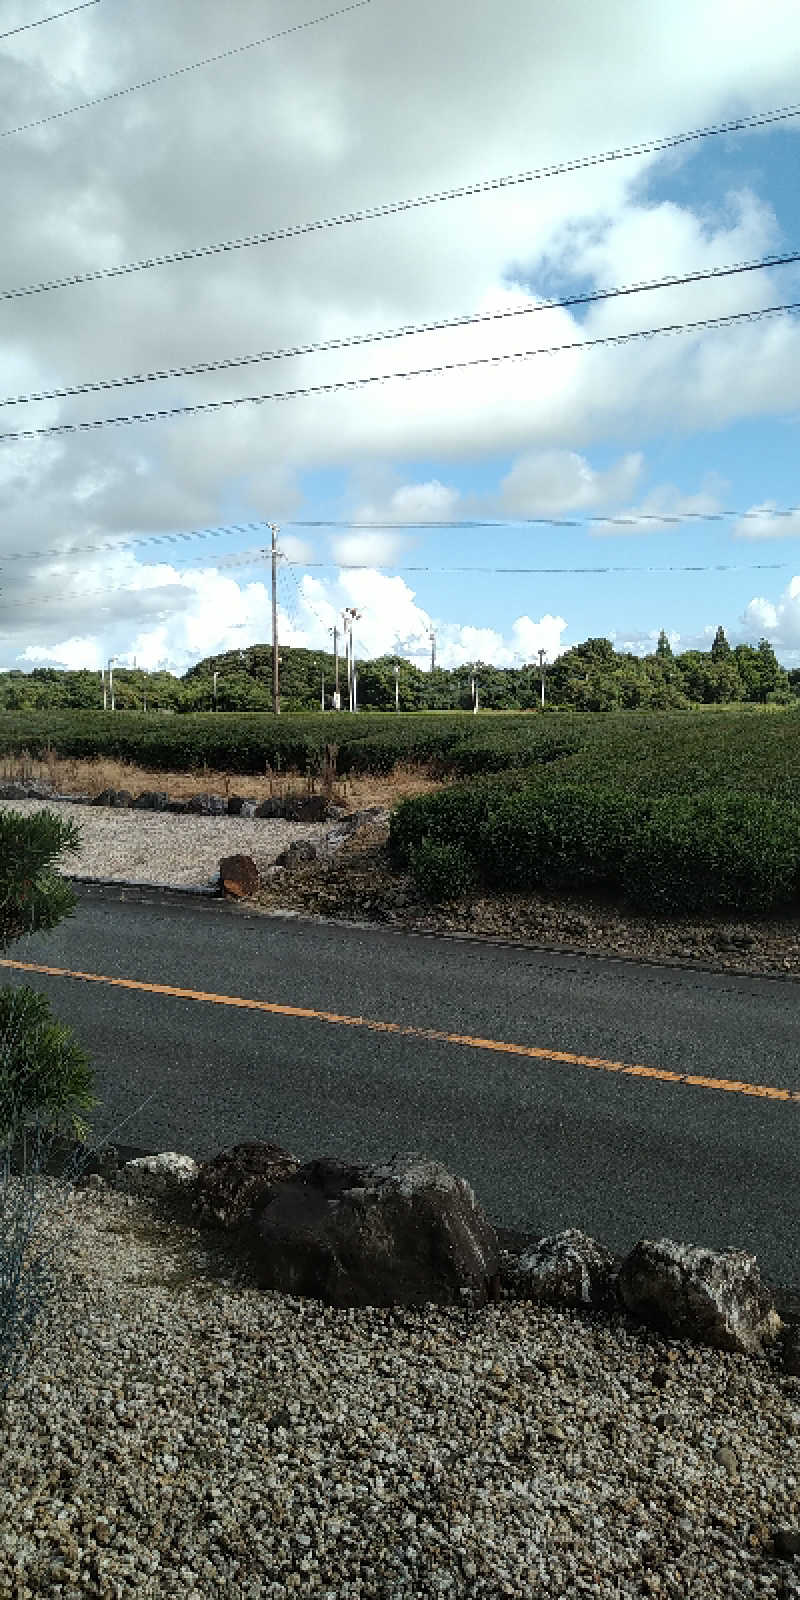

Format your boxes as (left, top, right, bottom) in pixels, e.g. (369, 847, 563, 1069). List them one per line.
(502, 1227, 616, 1309)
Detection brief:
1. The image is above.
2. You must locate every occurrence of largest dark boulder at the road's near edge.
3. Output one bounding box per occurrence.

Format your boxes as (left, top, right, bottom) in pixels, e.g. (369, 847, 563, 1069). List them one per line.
(246, 1155, 499, 1307)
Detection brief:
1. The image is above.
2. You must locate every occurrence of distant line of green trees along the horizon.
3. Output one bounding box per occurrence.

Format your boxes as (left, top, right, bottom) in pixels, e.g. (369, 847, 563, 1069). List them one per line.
(0, 627, 800, 712)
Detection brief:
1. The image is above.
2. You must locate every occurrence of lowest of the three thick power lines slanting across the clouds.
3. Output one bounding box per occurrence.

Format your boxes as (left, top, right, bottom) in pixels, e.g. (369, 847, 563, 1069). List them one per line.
(0, 301, 800, 445)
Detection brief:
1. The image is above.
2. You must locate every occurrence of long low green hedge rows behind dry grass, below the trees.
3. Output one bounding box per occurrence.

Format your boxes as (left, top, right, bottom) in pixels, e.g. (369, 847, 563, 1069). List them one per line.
(0, 707, 800, 803)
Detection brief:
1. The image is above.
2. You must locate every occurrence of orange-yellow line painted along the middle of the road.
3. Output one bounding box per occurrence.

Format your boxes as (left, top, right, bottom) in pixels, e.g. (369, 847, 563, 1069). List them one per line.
(0, 958, 800, 1102)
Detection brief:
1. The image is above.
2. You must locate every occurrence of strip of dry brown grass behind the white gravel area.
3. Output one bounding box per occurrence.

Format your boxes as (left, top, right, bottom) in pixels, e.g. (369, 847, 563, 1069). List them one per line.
(0, 754, 442, 811)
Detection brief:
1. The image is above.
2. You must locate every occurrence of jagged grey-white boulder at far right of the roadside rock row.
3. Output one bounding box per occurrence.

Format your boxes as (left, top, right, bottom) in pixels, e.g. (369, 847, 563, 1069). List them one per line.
(618, 1238, 782, 1355)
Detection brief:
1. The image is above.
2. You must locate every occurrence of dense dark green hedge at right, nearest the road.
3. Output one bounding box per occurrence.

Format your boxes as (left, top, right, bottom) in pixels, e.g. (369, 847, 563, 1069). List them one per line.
(389, 776, 800, 912)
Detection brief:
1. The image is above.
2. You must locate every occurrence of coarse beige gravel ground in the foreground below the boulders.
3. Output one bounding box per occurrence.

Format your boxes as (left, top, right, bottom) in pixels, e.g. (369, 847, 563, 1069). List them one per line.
(0, 1190, 800, 1600)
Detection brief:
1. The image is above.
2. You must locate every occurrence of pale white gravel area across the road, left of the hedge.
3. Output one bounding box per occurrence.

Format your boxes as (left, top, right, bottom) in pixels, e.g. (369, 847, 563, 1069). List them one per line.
(0, 800, 330, 888)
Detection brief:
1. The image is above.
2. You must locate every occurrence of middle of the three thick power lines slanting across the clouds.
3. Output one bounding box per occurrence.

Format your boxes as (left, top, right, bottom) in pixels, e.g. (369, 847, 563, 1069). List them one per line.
(6, 250, 800, 406)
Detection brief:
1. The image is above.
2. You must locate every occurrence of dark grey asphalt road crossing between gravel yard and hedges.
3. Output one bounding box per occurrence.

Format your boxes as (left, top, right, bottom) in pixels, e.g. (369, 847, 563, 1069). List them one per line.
(0, 891, 800, 1286)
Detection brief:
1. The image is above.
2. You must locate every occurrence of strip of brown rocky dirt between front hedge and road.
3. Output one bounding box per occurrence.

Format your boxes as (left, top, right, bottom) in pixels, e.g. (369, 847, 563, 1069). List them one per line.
(254, 827, 800, 978)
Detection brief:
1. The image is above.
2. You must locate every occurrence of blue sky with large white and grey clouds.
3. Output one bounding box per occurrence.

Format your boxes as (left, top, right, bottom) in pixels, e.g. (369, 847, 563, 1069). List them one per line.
(0, 0, 800, 672)
